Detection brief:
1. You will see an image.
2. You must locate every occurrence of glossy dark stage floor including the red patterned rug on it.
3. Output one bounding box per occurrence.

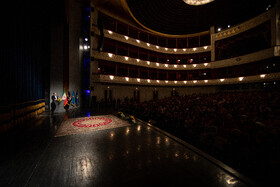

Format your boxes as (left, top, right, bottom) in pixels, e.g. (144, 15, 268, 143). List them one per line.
(0, 110, 254, 187)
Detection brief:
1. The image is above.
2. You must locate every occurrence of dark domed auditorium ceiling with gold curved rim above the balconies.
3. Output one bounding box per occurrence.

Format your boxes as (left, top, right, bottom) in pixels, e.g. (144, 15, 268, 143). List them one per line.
(93, 0, 275, 35)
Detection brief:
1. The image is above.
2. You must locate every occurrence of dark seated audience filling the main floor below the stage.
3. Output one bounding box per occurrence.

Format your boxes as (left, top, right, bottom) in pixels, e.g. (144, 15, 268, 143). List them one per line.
(121, 91, 280, 183)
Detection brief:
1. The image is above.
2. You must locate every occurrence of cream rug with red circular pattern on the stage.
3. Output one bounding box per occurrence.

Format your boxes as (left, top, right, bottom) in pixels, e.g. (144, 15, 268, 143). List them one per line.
(55, 115, 130, 137)
